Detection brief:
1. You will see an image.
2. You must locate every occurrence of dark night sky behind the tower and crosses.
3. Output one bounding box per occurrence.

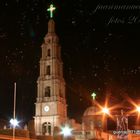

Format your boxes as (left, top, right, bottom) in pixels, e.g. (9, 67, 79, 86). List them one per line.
(0, 0, 140, 121)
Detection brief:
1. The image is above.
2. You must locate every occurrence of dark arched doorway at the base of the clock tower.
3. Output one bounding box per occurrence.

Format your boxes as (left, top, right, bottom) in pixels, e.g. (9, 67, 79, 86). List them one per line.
(42, 122, 51, 135)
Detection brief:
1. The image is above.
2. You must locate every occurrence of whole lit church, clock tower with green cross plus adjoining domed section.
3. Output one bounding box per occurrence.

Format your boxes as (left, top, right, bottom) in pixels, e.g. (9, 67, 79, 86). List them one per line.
(34, 5, 115, 140)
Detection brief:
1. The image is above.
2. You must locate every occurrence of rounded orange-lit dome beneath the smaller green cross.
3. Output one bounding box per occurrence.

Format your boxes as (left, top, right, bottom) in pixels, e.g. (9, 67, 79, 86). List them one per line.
(83, 106, 99, 117)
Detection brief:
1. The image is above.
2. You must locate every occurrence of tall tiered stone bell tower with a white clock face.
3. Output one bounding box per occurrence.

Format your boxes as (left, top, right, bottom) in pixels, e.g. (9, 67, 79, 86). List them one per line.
(34, 5, 67, 135)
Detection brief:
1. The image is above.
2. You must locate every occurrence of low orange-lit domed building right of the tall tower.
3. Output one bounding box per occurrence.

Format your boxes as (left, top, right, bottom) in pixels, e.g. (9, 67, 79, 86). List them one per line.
(69, 105, 116, 140)
